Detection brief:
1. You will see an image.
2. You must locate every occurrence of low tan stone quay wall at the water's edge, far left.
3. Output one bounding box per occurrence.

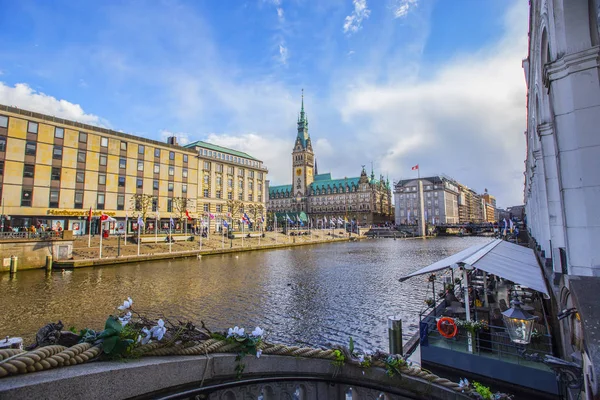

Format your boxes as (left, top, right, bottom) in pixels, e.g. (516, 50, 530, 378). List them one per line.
(0, 239, 73, 272)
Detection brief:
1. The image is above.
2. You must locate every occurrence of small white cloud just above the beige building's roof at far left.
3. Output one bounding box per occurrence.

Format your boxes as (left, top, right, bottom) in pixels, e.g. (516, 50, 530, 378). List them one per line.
(0, 82, 110, 127)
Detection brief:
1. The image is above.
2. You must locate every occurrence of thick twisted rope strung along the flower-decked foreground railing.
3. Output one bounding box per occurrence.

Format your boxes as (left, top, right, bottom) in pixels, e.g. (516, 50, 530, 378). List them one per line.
(0, 339, 463, 392)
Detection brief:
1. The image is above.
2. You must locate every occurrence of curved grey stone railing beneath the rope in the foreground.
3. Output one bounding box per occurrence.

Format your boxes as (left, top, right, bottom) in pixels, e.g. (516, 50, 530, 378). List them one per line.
(0, 354, 469, 400)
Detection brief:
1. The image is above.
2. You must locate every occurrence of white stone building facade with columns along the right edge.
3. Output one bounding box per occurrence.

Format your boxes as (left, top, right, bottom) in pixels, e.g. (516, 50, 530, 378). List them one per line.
(523, 0, 600, 399)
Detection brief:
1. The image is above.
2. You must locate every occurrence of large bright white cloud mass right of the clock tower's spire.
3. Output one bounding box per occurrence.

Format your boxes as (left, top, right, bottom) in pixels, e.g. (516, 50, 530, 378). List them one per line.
(335, 2, 528, 206)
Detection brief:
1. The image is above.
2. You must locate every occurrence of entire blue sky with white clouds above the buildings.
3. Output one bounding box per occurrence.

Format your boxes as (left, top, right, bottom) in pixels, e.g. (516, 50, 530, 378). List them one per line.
(0, 0, 528, 207)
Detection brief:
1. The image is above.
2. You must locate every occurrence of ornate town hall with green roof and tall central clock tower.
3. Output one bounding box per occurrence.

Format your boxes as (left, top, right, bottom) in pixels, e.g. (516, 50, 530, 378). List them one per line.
(267, 96, 393, 227)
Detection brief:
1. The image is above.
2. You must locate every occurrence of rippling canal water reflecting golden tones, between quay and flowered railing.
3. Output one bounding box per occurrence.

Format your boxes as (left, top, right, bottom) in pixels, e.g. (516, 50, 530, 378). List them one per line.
(0, 237, 489, 351)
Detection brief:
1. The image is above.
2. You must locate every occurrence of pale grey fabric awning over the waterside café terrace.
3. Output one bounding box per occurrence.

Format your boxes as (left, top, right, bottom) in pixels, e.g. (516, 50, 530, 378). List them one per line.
(400, 239, 549, 297)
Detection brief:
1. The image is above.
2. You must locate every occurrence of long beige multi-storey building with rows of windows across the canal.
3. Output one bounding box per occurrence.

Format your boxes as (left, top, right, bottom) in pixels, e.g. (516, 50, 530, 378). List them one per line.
(0, 105, 267, 234)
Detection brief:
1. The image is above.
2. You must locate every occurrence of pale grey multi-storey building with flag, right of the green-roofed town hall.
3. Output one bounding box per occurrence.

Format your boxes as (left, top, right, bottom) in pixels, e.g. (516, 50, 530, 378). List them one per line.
(394, 176, 460, 225)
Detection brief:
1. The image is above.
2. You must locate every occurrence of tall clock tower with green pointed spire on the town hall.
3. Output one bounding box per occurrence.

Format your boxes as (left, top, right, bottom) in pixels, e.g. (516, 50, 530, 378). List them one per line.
(292, 89, 315, 202)
